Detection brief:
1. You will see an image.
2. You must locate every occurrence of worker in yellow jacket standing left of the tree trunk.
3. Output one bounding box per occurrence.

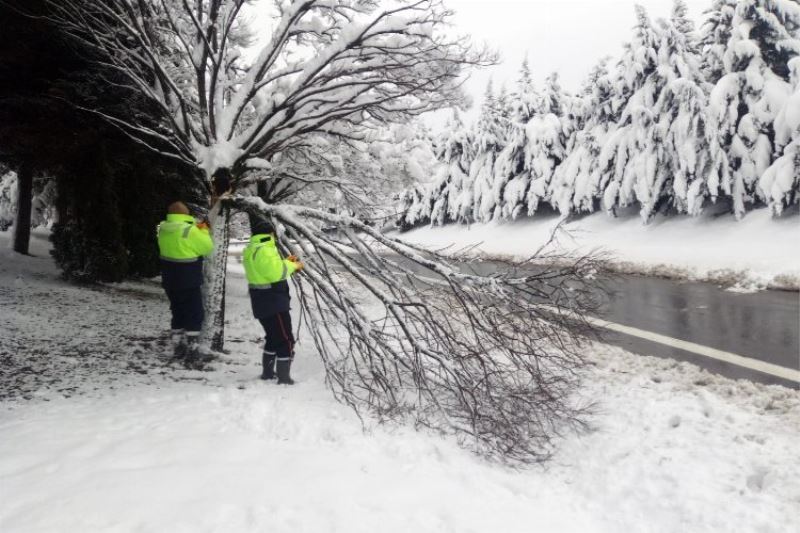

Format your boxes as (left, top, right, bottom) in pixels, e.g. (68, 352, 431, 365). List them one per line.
(158, 202, 214, 367)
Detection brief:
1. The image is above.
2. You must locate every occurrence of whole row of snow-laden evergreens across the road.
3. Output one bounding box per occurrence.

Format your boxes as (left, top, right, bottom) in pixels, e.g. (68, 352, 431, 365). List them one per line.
(400, 0, 800, 227)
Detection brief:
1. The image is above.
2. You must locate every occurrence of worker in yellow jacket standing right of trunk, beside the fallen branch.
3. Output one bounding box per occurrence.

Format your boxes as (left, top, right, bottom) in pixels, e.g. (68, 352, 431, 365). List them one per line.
(243, 221, 303, 385)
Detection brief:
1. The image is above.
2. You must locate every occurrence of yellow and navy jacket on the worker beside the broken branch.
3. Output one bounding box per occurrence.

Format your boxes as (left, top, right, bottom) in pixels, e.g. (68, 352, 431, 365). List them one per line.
(243, 233, 297, 319)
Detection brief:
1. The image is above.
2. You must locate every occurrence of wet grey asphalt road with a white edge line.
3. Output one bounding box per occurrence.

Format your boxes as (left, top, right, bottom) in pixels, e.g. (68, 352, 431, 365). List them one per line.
(378, 254, 800, 388)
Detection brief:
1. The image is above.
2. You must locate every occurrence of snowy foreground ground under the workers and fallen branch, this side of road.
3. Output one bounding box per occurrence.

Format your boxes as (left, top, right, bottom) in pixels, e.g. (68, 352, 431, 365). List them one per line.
(0, 230, 800, 533)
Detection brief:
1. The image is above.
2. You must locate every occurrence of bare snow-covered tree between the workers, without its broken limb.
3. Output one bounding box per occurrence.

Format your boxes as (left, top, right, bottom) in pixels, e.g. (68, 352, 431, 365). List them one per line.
(50, 0, 491, 348)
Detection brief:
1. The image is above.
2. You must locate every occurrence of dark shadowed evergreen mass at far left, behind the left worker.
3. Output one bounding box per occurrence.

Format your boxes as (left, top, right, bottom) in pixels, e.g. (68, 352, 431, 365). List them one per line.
(0, 0, 193, 274)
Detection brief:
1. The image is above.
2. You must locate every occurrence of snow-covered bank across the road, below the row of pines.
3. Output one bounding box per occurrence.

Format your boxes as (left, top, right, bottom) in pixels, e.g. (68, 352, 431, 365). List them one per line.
(401, 209, 800, 290)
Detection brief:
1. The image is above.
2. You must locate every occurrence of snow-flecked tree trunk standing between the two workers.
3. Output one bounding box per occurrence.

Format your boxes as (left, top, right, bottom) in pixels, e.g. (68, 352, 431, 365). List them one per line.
(201, 202, 230, 352)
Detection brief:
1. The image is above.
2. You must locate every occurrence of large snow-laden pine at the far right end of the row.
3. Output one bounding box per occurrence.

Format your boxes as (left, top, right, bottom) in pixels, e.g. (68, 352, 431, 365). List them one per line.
(708, 0, 800, 218)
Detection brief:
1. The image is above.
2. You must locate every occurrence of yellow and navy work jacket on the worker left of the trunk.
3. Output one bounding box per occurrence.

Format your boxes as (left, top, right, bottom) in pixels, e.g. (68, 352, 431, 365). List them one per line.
(158, 214, 214, 290)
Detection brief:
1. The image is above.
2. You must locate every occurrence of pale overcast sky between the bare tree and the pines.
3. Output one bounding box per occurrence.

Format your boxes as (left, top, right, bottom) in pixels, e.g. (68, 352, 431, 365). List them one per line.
(432, 0, 711, 122)
